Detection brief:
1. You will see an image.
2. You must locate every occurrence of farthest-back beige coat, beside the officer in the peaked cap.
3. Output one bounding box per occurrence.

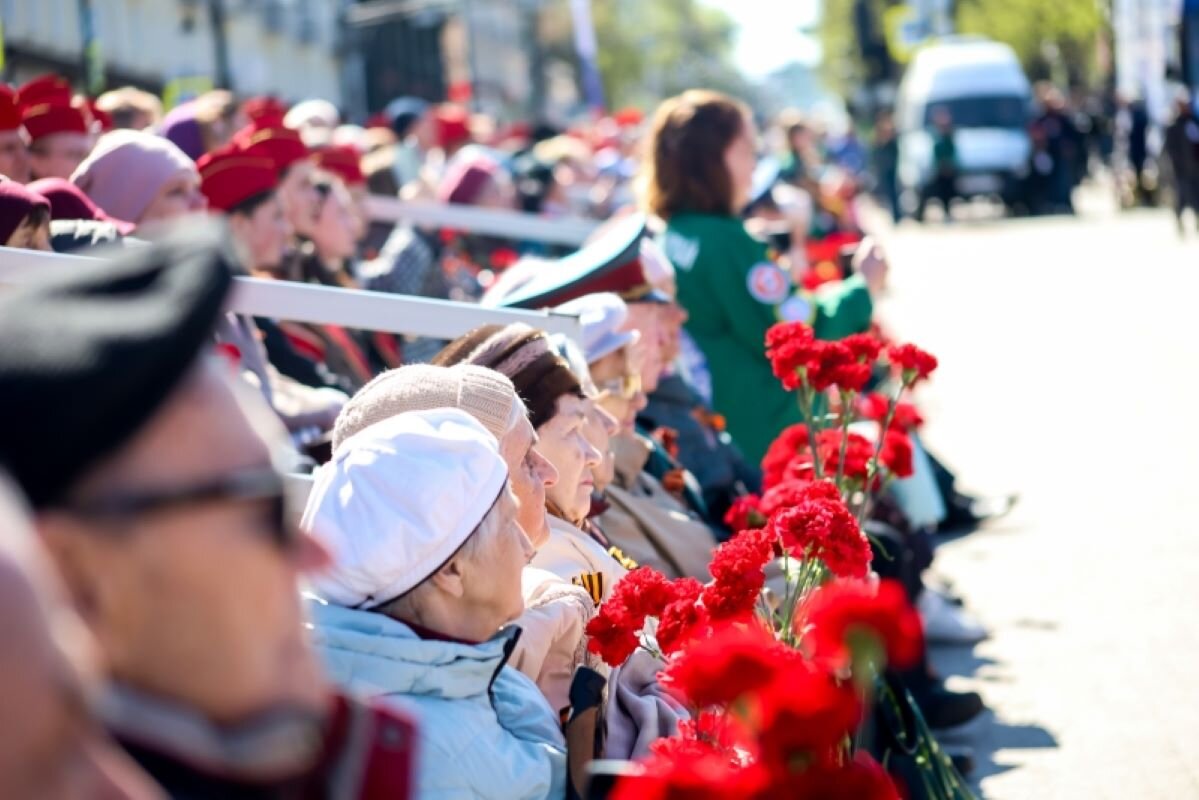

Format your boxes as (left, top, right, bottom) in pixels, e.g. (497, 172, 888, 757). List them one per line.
(596, 437, 716, 581)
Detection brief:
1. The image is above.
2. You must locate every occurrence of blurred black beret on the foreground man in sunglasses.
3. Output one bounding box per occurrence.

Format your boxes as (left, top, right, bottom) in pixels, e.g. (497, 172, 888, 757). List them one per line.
(0, 224, 233, 509)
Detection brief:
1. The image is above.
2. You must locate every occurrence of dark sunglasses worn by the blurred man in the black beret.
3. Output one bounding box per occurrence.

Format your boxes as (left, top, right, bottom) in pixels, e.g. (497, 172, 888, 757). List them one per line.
(62, 467, 300, 551)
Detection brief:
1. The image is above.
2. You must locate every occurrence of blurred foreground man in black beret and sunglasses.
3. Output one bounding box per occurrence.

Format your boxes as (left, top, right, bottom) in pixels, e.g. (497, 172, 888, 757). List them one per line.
(0, 230, 412, 798)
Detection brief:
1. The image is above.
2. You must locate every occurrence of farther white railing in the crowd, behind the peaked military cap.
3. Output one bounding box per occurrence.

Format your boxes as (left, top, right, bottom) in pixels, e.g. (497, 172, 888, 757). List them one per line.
(367, 194, 600, 247)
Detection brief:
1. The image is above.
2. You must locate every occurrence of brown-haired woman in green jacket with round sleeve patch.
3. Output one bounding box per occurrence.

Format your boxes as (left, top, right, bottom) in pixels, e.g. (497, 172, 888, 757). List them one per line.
(645, 90, 873, 461)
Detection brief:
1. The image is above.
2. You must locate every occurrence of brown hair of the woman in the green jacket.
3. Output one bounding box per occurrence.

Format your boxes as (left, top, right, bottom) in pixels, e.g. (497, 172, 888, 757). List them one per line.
(644, 89, 749, 219)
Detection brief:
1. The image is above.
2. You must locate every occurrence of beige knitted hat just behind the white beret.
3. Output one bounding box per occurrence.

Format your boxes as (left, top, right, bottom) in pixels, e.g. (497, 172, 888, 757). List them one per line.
(333, 363, 517, 451)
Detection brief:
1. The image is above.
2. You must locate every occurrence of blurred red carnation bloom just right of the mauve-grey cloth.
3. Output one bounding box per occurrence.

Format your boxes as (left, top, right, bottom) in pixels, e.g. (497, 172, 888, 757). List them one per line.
(659, 625, 805, 708)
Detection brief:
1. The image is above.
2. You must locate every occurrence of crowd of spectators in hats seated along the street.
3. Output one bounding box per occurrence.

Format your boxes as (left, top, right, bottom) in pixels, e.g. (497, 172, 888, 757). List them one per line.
(0, 76, 1014, 798)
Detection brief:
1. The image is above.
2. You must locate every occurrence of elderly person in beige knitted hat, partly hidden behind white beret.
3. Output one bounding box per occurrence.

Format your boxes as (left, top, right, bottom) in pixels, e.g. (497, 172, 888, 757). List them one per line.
(333, 365, 603, 709)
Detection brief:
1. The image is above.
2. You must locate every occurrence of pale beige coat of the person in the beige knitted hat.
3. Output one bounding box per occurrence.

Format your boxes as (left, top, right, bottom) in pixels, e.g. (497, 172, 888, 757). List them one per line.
(508, 566, 607, 711)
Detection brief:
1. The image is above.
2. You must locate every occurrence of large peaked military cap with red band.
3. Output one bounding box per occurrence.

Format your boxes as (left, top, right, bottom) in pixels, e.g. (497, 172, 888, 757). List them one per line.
(495, 213, 670, 308)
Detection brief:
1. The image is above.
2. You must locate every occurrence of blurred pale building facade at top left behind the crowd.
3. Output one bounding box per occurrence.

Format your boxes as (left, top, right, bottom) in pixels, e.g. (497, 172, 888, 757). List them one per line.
(0, 0, 343, 102)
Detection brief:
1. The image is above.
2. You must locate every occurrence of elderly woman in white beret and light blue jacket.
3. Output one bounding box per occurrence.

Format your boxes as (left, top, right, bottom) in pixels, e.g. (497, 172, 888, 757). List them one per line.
(302, 409, 567, 799)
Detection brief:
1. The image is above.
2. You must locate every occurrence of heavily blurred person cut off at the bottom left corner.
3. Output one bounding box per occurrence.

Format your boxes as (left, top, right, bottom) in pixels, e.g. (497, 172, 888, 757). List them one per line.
(0, 480, 161, 800)
